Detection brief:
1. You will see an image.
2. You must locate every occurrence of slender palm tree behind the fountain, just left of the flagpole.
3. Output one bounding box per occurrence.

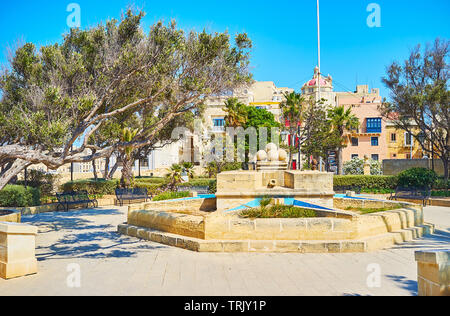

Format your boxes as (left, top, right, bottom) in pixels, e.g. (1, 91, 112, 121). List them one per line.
(280, 92, 305, 168)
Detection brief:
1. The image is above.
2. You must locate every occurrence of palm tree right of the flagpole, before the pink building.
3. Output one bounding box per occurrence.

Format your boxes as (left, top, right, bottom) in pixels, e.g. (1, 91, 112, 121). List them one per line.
(328, 105, 359, 174)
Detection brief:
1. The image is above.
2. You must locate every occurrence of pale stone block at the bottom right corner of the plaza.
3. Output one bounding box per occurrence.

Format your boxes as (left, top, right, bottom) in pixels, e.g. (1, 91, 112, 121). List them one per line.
(415, 250, 450, 296)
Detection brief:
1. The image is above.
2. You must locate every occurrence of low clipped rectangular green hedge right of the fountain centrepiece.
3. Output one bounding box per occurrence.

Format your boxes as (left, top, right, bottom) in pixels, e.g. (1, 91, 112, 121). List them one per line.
(333, 176, 397, 190)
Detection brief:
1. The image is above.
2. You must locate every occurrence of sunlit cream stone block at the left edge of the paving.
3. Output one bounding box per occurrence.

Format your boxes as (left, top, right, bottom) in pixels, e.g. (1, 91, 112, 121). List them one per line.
(0, 222, 37, 279)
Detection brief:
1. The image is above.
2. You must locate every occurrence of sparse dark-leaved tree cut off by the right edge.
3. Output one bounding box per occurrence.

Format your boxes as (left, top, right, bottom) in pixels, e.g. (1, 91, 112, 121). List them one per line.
(380, 39, 450, 179)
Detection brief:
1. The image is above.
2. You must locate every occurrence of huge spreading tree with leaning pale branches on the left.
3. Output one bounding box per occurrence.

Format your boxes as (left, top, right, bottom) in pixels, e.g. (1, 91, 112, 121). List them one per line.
(0, 10, 251, 189)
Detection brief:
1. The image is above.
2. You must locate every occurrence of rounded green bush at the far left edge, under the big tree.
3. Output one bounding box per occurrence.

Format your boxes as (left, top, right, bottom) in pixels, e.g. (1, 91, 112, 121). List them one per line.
(0, 185, 41, 207)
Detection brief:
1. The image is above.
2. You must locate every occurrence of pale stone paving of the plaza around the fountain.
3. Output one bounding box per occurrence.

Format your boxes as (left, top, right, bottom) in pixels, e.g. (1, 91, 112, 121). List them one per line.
(0, 207, 450, 296)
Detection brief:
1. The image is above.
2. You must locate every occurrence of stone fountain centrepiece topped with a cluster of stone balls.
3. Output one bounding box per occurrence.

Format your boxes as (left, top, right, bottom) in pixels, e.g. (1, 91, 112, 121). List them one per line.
(216, 143, 334, 211)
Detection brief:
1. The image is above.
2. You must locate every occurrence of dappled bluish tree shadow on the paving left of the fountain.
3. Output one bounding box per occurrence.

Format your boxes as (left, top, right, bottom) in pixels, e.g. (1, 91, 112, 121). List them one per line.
(22, 209, 168, 261)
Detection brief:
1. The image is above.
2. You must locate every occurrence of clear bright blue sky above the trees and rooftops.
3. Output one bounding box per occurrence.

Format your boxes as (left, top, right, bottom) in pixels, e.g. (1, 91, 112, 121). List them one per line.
(0, 0, 450, 97)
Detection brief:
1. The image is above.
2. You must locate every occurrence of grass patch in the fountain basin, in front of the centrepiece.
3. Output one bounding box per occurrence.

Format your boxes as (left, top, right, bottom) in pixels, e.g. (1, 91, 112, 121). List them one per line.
(239, 205, 317, 218)
